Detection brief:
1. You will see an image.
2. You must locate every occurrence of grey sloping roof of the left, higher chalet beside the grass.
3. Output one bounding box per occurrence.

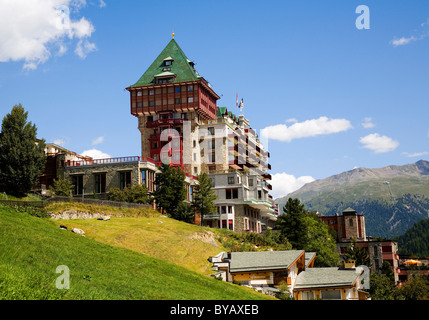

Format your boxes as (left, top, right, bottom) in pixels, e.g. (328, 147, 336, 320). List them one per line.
(229, 250, 304, 272)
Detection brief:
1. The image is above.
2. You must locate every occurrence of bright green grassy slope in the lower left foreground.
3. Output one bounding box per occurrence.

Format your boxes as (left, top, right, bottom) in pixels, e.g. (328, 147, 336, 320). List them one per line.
(0, 206, 266, 300)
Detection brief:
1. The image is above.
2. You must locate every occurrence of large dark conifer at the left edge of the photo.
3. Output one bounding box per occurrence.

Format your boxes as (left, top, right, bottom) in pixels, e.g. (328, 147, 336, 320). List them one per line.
(0, 104, 46, 196)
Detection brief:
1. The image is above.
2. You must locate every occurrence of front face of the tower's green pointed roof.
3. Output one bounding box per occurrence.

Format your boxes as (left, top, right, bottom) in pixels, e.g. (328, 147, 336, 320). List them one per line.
(131, 39, 200, 87)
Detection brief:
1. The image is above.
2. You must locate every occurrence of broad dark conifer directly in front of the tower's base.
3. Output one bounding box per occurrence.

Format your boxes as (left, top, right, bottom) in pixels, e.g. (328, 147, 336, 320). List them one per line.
(152, 164, 186, 218)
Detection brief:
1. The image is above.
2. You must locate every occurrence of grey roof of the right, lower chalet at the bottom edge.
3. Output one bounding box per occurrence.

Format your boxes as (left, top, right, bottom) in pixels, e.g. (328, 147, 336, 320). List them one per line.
(294, 267, 359, 290)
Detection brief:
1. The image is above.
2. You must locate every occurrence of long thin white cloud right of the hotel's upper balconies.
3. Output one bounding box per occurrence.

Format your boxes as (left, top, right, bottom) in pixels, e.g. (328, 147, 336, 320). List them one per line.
(261, 117, 352, 142)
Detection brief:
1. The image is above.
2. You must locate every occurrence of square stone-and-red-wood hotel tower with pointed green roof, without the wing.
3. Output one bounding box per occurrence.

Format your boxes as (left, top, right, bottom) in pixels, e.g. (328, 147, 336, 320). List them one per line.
(126, 36, 219, 174)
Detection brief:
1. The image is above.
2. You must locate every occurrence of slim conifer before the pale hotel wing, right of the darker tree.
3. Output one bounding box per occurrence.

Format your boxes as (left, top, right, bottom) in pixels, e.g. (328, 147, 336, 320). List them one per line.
(192, 172, 217, 225)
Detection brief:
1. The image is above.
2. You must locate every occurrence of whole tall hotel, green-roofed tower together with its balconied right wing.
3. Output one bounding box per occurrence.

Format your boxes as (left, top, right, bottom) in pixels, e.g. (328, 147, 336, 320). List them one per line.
(126, 38, 277, 233)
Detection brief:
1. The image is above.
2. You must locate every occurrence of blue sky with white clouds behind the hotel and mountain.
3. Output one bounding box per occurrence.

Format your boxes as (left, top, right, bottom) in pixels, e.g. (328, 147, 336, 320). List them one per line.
(0, 0, 429, 198)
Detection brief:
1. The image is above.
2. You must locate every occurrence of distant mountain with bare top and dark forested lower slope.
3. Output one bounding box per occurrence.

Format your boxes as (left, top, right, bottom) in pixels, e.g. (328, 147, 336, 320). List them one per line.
(275, 160, 429, 238)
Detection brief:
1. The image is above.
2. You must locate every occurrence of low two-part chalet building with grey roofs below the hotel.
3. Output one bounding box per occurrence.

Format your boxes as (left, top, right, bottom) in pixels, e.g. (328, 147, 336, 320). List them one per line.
(209, 250, 369, 300)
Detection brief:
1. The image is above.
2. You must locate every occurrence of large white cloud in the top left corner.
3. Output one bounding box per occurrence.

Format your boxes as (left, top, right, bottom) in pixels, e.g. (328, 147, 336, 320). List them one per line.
(0, 0, 95, 70)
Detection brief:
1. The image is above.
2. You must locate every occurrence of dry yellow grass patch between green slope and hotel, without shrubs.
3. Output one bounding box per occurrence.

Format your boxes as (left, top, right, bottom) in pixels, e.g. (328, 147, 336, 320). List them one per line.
(57, 217, 225, 274)
